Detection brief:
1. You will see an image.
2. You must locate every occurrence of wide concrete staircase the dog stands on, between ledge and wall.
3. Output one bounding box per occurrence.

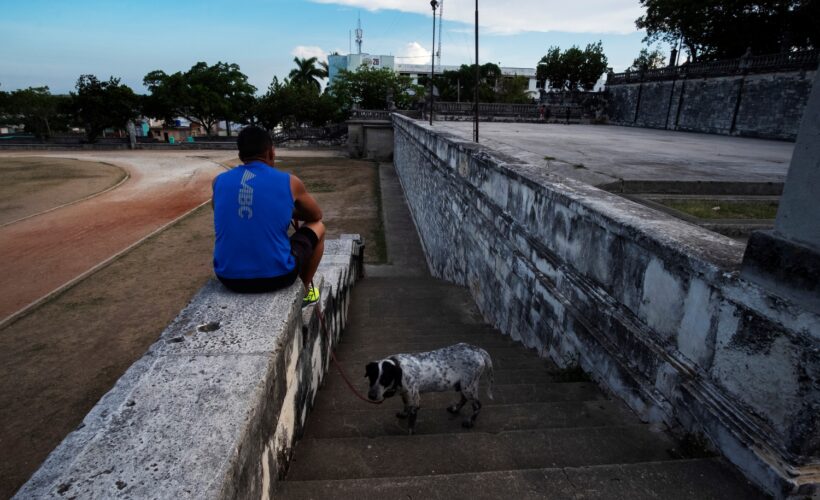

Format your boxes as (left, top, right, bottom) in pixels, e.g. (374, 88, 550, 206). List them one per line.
(276, 166, 762, 499)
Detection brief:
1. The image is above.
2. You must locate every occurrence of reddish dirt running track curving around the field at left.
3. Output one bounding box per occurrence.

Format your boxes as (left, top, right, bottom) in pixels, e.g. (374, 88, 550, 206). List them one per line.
(0, 151, 233, 321)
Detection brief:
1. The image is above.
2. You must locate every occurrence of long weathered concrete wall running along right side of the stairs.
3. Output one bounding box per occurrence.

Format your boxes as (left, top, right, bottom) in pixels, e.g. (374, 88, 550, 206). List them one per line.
(394, 116, 820, 495)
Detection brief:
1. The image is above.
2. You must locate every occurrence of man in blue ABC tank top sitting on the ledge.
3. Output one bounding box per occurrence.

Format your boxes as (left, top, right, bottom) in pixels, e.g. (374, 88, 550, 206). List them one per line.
(211, 126, 325, 305)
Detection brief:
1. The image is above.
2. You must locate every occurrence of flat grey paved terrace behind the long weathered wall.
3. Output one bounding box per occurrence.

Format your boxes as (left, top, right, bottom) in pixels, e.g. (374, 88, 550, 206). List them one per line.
(434, 122, 794, 186)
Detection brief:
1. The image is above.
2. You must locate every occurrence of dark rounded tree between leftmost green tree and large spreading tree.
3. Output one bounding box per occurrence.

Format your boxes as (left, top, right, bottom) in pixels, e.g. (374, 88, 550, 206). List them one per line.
(71, 75, 139, 142)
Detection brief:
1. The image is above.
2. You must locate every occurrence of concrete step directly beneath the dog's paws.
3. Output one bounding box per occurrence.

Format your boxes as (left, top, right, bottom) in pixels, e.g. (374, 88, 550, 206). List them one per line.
(304, 398, 636, 439)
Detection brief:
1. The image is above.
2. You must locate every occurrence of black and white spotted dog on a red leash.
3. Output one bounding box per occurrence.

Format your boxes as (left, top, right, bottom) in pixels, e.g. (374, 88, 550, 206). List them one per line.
(364, 343, 493, 434)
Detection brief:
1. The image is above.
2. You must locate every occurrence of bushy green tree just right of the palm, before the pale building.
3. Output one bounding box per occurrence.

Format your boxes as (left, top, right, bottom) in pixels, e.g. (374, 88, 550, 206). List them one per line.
(328, 67, 424, 113)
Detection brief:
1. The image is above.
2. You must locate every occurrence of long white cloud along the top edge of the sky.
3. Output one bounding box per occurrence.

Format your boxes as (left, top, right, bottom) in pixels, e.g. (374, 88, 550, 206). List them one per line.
(311, 0, 643, 35)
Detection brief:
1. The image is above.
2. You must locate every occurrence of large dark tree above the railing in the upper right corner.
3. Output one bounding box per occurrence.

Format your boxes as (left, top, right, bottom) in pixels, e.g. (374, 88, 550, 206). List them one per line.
(635, 0, 820, 61)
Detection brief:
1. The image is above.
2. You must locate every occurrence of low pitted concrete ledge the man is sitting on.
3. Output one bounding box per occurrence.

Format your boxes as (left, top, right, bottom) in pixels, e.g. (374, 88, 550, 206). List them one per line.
(15, 235, 364, 499)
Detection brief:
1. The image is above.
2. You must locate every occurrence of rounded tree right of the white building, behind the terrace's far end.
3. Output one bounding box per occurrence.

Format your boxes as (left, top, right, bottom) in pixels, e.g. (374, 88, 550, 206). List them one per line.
(536, 41, 608, 91)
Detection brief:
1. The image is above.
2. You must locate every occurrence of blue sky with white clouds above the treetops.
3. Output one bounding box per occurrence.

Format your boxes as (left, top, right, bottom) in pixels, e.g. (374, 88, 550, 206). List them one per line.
(0, 0, 668, 93)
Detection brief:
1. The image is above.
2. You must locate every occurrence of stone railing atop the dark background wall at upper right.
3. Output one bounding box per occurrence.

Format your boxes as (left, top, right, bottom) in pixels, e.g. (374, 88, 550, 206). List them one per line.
(606, 51, 818, 86)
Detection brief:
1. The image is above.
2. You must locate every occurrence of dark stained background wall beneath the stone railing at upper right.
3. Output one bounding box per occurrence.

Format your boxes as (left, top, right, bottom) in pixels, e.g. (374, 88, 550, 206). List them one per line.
(607, 71, 815, 141)
